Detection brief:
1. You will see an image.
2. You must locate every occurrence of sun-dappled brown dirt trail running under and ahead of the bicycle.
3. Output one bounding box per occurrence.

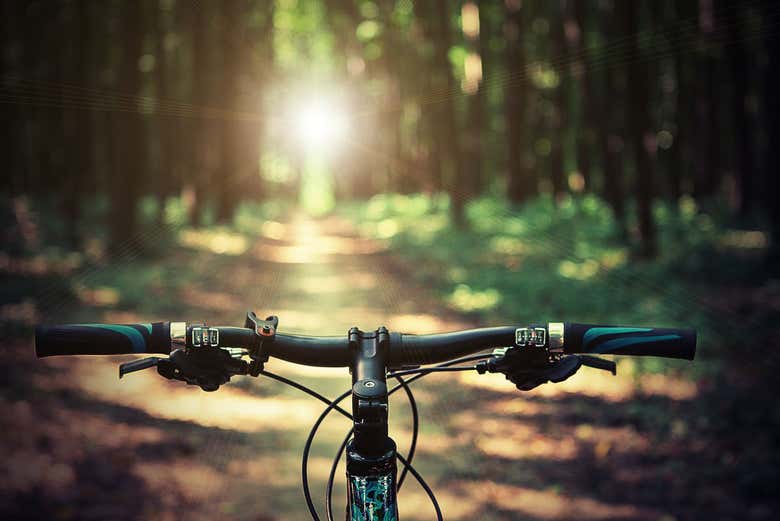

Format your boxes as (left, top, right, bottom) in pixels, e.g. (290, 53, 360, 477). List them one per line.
(0, 212, 728, 521)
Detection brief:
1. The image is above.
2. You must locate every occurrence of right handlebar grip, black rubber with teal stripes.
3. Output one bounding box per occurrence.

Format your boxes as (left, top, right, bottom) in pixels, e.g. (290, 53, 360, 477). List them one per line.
(563, 322, 696, 360)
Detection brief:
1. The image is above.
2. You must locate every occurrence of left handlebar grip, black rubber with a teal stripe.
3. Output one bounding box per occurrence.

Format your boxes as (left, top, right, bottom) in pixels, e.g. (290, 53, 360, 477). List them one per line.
(35, 322, 171, 357)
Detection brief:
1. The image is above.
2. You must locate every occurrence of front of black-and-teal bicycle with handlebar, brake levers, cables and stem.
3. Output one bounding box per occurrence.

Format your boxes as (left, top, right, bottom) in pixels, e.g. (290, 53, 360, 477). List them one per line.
(35, 312, 696, 521)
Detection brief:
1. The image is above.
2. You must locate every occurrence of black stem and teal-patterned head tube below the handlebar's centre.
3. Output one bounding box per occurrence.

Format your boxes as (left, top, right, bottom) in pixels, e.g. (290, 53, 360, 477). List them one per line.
(346, 327, 398, 521)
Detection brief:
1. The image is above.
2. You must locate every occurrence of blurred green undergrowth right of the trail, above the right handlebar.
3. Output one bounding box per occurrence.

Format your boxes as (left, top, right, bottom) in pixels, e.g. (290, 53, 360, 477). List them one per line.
(345, 194, 760, 372)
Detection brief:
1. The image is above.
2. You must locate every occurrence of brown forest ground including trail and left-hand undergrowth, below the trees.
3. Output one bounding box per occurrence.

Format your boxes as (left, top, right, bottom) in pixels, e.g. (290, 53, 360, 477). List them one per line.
(0, 208, 780, 521)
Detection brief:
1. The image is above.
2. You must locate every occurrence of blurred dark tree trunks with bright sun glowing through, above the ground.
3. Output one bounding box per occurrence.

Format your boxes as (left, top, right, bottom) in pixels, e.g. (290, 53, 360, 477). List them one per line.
(2, 0, 779, 258)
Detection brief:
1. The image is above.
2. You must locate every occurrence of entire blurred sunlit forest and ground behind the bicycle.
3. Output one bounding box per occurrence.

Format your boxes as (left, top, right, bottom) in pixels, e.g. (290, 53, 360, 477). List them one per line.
(0, 0, 780, 521)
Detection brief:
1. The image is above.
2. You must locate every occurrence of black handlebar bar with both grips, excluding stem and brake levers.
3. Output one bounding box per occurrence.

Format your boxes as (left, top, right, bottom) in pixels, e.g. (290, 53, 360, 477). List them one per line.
(35, 322, 696, 367)
